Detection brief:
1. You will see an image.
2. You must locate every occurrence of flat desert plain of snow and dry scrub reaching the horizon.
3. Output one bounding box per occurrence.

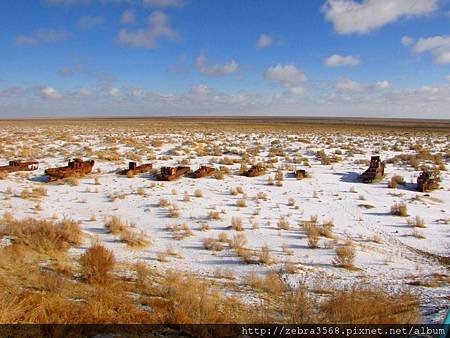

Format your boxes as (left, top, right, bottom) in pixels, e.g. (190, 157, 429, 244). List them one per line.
(0, 118, 450, 322)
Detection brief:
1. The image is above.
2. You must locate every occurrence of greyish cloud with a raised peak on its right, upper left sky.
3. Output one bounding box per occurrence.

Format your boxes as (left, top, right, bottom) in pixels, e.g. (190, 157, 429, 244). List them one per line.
(117, 11, 179, 48)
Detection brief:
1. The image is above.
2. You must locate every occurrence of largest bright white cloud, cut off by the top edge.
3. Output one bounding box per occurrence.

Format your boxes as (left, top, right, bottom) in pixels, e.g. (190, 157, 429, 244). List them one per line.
(322, 0, 438, 34)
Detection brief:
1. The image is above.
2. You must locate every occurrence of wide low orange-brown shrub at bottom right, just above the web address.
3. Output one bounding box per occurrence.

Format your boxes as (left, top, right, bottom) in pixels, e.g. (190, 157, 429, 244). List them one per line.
(320, 286, 421, 324)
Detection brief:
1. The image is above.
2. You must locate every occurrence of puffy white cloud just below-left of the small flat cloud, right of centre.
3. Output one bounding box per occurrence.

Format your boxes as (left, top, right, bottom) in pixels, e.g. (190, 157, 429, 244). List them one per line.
(264, 64, 308, 95)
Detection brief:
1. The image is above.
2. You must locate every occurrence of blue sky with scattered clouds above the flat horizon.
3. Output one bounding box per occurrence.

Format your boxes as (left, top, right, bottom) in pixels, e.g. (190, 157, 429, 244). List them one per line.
(0, 0, 450, 119)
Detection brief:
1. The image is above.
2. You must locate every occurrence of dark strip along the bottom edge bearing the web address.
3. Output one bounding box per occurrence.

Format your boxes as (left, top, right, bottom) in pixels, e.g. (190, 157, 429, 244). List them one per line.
(0, 324, 450, 338)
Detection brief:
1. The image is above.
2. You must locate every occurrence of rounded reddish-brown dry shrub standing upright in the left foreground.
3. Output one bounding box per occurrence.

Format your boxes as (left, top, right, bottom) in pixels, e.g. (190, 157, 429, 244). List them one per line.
(80, 244, 116, 284)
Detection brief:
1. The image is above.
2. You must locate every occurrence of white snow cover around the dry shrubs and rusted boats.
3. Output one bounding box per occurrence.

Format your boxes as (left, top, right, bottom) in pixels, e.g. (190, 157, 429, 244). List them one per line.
(0, 128, 450, 320)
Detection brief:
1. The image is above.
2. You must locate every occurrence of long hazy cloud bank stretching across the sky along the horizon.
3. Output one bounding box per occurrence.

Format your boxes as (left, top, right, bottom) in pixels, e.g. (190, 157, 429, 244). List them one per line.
(4, 80, 450, 119)
